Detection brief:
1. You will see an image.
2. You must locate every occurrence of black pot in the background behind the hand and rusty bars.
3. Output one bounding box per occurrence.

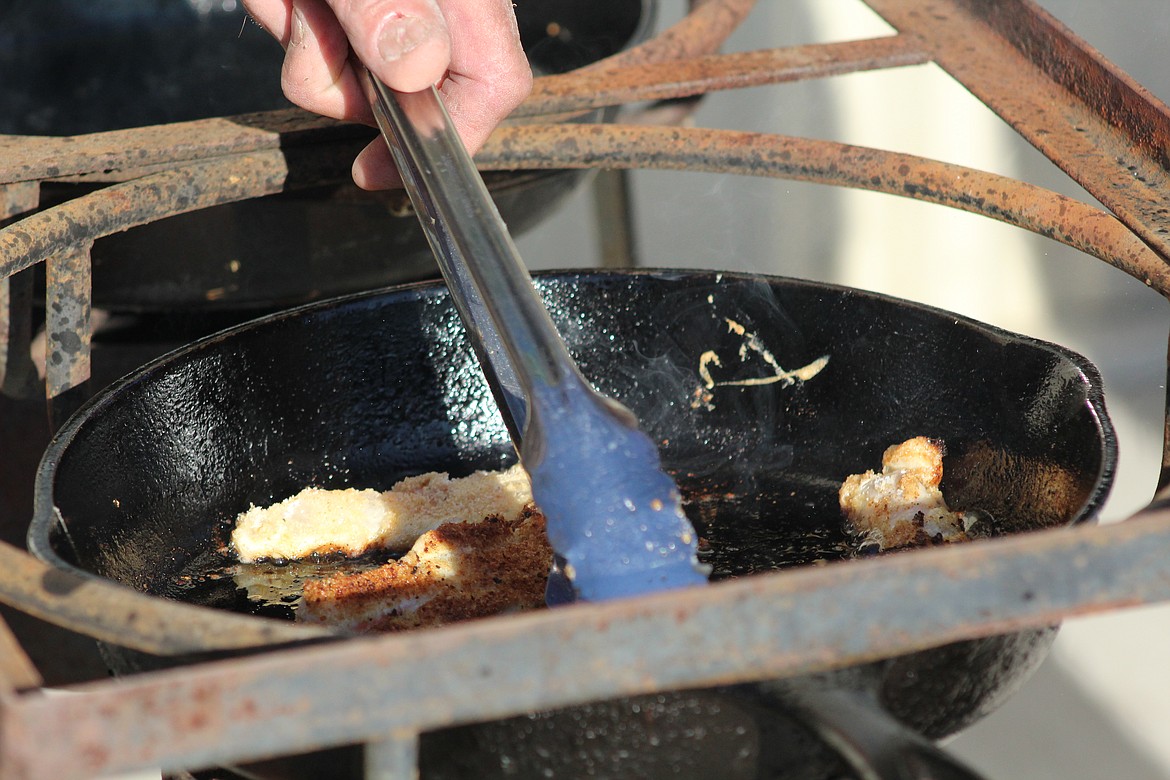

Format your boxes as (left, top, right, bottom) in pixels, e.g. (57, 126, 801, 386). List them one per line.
(0, 0, 656, 311)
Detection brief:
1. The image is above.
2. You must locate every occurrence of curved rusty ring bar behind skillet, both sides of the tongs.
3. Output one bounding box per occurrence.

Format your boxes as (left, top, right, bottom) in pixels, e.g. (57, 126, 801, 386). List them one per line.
(0, 125, 1170, 394)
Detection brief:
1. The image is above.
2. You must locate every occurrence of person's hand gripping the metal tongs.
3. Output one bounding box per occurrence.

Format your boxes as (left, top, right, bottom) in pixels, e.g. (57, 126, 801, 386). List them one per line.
(243, 0, 532, 189)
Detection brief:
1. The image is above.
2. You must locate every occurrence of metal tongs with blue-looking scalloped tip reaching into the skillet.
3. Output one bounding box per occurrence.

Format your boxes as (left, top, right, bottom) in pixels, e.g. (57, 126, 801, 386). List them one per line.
(366, 71, 707, 605)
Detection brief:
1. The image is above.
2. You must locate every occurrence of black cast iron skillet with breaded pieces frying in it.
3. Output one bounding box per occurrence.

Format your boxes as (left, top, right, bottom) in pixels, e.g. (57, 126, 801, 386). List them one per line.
(29, 271, 1116, 776)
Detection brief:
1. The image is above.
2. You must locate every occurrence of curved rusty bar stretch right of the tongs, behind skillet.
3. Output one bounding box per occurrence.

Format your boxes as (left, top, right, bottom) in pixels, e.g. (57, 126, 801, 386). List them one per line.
(476, 125, 1170, 296)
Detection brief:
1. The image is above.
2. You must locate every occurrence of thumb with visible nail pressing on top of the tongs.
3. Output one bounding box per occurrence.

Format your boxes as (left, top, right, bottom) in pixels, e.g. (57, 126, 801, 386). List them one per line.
(330, 0, 450, 92)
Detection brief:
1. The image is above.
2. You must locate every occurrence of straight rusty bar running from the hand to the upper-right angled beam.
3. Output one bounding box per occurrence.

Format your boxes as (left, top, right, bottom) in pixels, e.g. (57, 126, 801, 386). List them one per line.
(512, 35, 930, 117)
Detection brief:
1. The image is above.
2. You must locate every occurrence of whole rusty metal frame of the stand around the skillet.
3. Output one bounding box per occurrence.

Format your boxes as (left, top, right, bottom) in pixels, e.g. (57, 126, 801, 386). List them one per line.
(0, 0, 1170, 778)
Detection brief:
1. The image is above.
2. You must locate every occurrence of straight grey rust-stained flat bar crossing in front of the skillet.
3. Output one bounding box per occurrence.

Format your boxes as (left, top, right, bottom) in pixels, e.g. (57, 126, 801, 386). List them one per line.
(0, 510, 1170, 778)
